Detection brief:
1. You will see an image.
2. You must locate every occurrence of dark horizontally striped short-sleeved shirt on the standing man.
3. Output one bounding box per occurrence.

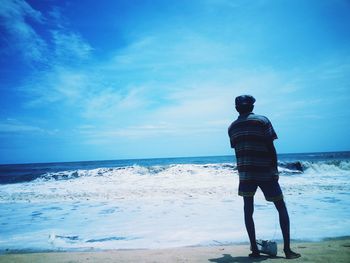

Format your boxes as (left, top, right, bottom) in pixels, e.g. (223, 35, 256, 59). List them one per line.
(228, 113, 278, 181)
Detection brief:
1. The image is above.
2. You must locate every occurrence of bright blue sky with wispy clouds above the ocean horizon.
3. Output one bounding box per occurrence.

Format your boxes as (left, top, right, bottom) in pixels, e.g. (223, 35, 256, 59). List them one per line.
(0, 0, 350, 163)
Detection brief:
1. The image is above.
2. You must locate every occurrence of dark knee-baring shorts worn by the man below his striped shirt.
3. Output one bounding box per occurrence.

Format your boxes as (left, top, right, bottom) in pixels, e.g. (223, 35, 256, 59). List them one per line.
(238, 180, 283, 202)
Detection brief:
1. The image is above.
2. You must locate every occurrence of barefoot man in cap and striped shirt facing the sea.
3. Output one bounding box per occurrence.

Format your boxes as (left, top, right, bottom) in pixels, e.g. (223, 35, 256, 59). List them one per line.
(228, 95, 300, 259)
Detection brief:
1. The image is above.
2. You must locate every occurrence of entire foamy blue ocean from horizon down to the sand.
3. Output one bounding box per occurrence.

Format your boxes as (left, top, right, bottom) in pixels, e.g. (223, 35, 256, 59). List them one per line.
(0, 152, 350, 253)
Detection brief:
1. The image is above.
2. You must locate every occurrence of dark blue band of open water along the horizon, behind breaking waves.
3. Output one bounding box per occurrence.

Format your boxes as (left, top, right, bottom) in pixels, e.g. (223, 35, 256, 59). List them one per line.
(0, 151, 350, 184)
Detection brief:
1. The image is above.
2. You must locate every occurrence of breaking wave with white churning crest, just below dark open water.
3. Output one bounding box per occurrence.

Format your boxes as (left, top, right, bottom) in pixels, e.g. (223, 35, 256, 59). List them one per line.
(0, 160, 350, 184)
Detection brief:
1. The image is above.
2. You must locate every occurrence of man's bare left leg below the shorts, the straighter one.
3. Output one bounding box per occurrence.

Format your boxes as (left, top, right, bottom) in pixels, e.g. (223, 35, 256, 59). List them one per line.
(243, 196, 259, 257)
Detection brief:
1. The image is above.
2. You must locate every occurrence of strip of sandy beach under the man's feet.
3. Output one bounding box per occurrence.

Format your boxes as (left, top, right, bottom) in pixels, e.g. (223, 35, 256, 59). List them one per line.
(0, 237, 350, 263)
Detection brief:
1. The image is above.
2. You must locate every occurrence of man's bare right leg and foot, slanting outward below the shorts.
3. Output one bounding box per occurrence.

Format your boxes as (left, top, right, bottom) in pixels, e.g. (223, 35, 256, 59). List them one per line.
(274, 199, 300, 259)
